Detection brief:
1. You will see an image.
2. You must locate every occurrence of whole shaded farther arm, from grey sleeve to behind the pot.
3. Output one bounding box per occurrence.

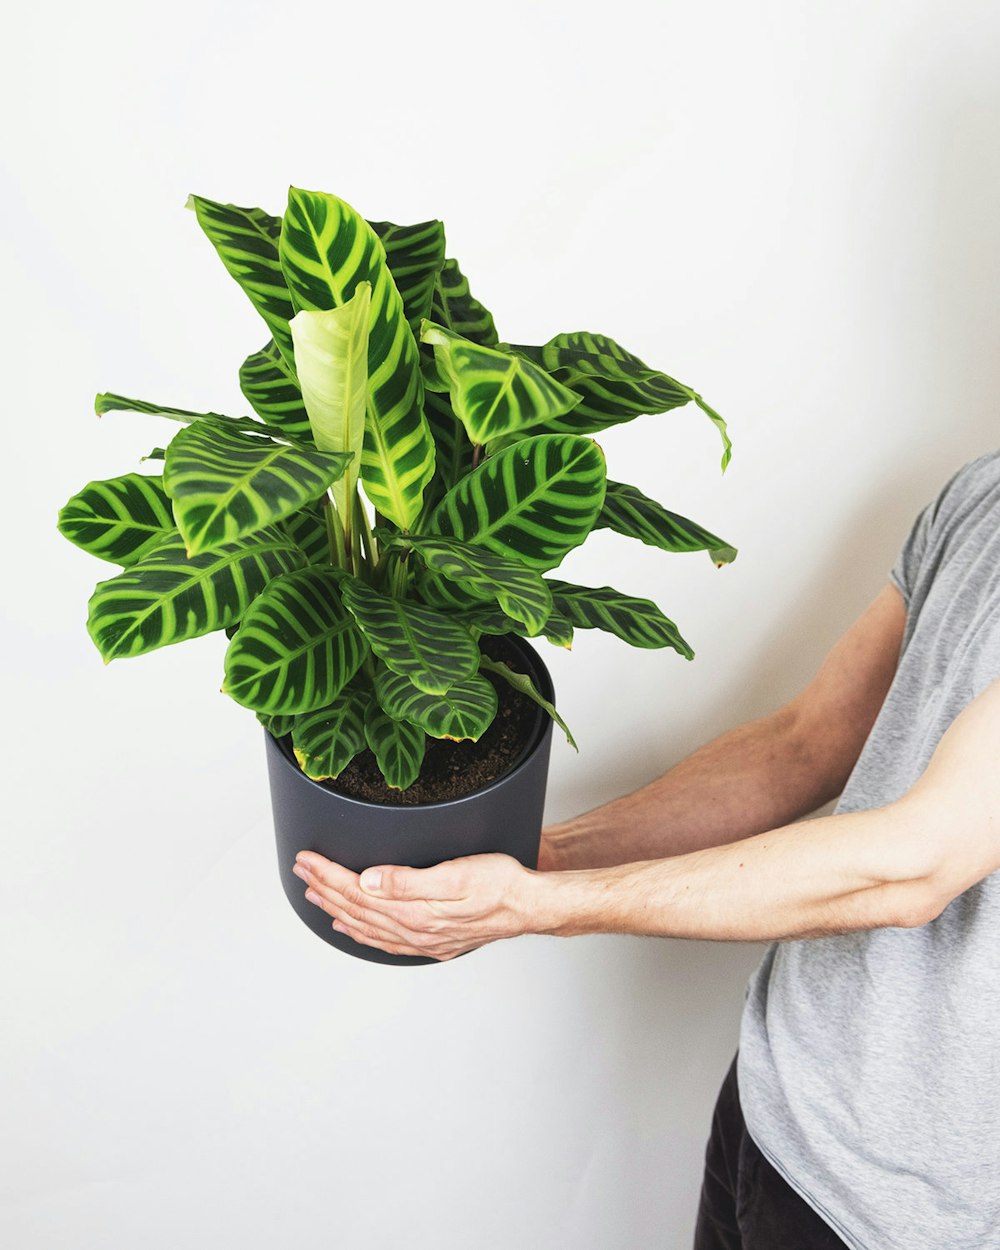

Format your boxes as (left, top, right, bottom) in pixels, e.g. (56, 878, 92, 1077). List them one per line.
(539, 585, 906, 871)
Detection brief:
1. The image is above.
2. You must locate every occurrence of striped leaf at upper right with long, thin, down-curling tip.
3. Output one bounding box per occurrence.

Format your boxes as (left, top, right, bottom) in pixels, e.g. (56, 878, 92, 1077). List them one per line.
(503, 331, 733, 469)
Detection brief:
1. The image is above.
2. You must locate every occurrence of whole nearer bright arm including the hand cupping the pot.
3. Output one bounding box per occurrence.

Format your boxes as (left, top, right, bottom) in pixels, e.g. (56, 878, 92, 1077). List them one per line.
(296, 681, 1000, 959)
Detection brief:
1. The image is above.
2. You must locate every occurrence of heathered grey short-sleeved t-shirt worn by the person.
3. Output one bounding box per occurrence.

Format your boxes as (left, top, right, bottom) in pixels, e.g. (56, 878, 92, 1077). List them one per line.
(739, 451, 1000, 1250)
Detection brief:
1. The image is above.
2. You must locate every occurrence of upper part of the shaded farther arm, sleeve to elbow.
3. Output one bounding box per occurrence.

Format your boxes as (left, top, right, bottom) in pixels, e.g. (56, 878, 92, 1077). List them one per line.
(788, 583, 906, 799)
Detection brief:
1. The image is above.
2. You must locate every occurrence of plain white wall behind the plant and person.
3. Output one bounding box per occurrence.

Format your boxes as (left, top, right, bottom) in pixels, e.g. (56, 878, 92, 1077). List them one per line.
(0, 0, 1000, 1250)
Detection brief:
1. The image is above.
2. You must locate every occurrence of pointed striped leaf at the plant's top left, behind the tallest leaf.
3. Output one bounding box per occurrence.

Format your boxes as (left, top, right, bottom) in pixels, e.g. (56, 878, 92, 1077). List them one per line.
(188, 195, 295, 370)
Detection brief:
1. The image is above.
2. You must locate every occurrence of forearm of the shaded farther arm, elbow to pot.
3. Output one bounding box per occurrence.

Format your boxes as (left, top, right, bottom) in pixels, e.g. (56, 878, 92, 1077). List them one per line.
(540, 709, 853, 870)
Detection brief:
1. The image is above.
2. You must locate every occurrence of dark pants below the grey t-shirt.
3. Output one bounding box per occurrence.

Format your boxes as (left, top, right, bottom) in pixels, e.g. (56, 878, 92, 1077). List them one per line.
(695, 1059, 848, 1250)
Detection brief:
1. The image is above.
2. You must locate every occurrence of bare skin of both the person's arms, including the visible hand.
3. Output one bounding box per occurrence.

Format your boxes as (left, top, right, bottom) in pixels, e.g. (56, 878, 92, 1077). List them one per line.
(294, 585, 1000, 960)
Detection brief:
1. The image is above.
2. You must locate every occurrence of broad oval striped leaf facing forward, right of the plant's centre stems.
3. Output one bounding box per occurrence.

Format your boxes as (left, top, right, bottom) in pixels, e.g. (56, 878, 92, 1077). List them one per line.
(428, 434, 605, 570)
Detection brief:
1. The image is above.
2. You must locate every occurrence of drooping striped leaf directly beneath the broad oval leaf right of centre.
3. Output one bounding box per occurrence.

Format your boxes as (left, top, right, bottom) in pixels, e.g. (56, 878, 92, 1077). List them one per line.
(386, 535, 553, 634)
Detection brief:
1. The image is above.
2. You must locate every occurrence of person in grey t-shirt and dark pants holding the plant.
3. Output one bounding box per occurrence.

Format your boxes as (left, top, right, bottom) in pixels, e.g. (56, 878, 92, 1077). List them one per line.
(287, 451, 1000, 1250)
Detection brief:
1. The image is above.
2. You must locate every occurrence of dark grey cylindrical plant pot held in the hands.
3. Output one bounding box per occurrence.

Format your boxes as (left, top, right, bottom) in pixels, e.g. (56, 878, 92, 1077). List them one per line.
(264, 635, 553, 965)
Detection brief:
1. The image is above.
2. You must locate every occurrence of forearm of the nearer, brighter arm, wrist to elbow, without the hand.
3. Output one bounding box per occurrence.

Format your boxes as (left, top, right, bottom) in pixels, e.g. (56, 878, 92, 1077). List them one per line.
(531, 801, 946, 941)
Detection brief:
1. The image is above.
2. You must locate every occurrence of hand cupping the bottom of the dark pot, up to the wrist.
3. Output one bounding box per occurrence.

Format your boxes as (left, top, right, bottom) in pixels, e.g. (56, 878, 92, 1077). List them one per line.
(293, 851, 539, 960)
